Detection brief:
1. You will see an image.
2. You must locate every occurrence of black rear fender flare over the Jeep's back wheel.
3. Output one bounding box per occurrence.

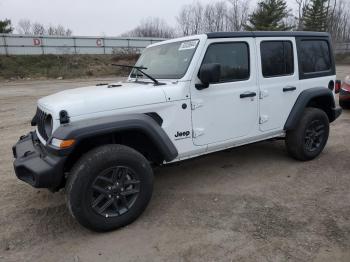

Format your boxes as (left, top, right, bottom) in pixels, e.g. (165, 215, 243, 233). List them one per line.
(284, 87, 341, 131)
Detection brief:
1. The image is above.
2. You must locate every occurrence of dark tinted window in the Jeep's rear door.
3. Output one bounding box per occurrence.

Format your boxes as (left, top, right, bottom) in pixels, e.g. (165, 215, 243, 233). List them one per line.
(260, 41, 294, 77)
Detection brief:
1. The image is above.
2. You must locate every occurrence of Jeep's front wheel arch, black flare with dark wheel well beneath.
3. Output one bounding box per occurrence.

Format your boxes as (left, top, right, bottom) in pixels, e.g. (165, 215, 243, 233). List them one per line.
(52, 114, 178, 170)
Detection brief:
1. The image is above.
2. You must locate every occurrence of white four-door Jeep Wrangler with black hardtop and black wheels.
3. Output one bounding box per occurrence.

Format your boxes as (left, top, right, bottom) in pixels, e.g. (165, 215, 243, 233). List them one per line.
(13, 32, 341, 231)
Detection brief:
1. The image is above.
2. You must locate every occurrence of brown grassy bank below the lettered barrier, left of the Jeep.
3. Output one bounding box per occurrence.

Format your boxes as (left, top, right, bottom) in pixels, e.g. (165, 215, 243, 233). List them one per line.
(0, 53, 139, 79)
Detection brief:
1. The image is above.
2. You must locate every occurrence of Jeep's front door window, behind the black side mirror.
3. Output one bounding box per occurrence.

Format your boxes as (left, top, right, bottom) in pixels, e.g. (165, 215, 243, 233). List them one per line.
(202, 42, 250, 82)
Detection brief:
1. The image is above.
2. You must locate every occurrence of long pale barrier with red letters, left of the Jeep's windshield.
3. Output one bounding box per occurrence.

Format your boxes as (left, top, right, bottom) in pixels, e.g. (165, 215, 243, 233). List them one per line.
(0, 34, 165, 55)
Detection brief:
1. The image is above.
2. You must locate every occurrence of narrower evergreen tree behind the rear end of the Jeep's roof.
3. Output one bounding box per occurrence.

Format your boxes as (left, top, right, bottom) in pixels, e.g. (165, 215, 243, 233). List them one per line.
(303, 0, 328, 32)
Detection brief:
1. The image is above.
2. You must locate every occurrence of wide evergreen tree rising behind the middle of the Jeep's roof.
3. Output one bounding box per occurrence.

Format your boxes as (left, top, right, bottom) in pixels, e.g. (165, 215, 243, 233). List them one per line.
(245, 0, 293, 31)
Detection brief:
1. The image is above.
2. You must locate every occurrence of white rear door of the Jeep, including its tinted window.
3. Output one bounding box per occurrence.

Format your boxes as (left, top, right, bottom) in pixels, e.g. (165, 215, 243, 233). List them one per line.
(256, 37, 300, 132)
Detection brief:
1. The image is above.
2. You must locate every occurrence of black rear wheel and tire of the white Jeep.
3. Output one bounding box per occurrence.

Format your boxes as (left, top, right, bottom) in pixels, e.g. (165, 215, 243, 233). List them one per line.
(286, 108, 329, 161)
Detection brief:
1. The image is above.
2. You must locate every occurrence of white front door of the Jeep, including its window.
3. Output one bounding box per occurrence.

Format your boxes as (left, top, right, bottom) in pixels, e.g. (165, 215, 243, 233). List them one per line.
(191, 38, 259, 145)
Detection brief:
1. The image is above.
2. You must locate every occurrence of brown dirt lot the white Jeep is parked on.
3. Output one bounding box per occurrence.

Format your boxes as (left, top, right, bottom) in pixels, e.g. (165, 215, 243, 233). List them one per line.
(0, 66, 350, 262)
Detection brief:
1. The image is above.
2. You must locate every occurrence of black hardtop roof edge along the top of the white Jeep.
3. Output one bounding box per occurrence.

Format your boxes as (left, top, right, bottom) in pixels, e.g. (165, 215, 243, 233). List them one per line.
(207, 31, 330, 38)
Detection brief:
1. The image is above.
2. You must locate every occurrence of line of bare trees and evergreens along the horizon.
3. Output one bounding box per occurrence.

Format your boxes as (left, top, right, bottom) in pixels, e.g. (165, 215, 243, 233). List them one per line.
(0, 0, 350, 41)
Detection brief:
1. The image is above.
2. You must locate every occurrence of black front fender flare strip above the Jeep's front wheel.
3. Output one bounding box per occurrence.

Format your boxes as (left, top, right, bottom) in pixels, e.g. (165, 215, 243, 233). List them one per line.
(49, 114, 178, 162)
